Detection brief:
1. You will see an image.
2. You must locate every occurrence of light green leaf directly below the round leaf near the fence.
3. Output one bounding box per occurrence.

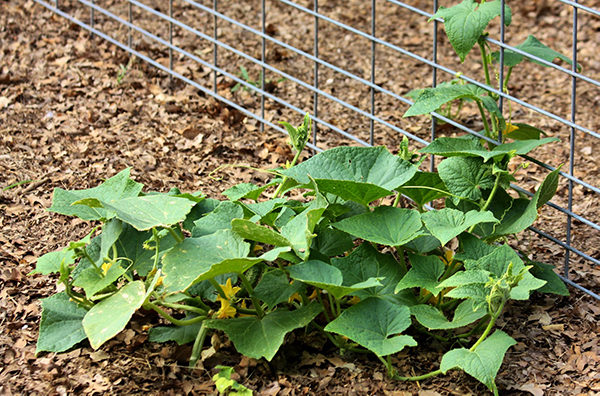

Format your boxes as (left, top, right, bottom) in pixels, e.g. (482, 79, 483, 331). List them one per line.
(421, 208, 498, 245)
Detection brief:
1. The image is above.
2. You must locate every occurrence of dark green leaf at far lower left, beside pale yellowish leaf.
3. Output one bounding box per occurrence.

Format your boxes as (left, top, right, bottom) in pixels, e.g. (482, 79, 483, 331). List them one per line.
(35, 292, 87, 354)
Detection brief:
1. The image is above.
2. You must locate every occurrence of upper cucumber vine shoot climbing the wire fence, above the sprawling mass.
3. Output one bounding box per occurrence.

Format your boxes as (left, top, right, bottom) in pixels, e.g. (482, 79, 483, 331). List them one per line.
(404, 0, 581, 142)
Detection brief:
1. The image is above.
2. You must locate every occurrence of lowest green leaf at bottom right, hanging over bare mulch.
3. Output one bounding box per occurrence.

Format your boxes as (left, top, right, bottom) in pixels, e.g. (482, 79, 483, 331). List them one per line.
(440, 330, 517, 393)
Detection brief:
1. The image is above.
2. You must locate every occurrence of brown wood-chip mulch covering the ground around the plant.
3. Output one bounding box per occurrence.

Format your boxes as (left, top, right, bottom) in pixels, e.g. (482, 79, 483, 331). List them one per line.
(0, 0, 600, 396)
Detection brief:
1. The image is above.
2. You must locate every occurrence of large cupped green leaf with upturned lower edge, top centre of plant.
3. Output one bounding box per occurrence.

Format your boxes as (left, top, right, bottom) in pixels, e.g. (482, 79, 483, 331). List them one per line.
(281, 147, 417, 205)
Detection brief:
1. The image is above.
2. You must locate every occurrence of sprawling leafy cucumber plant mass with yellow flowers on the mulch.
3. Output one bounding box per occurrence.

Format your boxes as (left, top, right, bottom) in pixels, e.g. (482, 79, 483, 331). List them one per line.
(34, 110, 567, 394)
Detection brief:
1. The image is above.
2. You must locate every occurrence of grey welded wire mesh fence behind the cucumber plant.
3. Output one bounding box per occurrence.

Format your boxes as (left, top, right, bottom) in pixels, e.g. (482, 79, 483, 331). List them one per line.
(35, 0, 600, 299)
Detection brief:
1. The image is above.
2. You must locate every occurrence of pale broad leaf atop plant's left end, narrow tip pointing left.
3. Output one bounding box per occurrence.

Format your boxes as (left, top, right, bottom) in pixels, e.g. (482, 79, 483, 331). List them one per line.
(74, 194, 196, 231)
